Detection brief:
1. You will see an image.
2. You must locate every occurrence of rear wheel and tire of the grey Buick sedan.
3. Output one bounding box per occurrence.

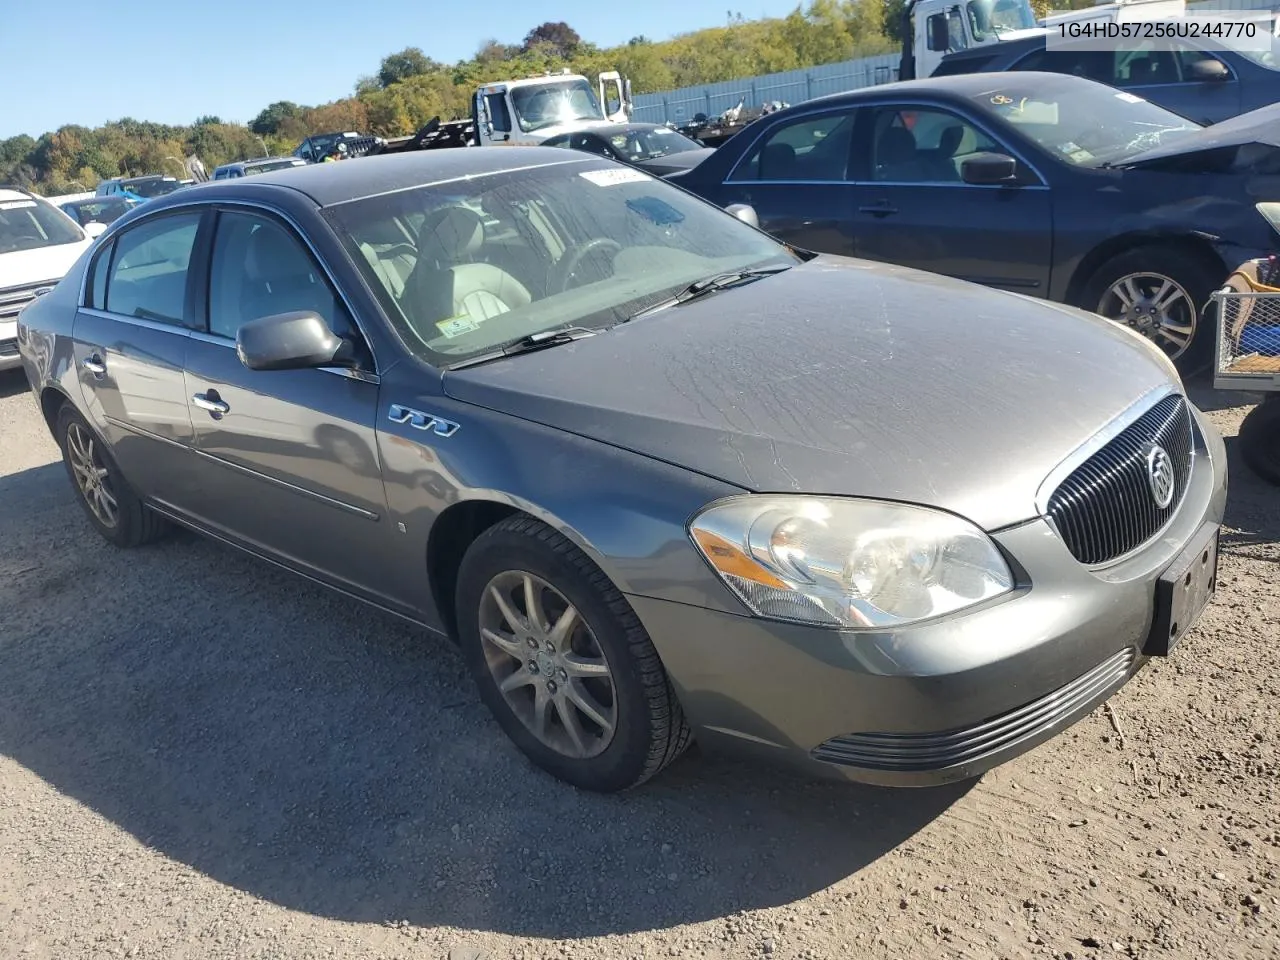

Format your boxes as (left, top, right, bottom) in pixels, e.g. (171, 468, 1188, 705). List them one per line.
(56, 403, 169, 547)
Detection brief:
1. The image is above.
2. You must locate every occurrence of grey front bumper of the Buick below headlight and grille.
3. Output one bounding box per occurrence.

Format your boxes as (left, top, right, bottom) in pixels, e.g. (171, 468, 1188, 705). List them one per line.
(628, 401, 1226, 786)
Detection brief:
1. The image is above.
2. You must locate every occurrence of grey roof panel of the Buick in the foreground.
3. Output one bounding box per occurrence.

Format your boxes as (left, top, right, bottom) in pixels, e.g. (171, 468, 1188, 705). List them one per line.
(176, 146, 603, 206)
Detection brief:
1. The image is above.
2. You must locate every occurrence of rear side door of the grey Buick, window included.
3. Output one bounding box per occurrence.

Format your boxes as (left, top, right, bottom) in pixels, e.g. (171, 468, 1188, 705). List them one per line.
(73, 212, 202, 503)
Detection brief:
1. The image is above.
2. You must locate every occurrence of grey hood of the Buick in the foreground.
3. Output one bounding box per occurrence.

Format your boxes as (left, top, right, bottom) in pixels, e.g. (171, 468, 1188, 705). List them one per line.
(444, 257, 1171, 530)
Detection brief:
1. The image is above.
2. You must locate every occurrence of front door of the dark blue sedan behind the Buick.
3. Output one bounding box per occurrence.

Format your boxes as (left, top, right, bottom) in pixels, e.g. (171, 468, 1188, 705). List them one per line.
(855, 104, 1053, 297)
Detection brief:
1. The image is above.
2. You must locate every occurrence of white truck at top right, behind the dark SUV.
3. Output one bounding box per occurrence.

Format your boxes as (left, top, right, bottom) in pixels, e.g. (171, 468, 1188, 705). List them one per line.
(899, 0, 1187, 79)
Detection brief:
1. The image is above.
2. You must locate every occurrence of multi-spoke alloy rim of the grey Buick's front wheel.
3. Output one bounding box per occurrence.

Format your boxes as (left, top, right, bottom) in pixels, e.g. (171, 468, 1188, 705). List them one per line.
(480, 570, 618, 759)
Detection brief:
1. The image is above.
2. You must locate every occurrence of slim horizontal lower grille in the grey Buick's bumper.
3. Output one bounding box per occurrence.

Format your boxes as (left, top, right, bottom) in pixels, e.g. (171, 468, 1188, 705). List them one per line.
(813, 648, 1135, 772)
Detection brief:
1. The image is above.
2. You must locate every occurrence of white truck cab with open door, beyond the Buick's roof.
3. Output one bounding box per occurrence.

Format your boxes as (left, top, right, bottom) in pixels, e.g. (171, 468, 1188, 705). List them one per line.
(471, 69, 632, 146)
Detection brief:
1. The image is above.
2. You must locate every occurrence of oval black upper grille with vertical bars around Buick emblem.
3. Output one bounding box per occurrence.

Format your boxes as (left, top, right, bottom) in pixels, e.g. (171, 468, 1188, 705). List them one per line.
(1047, 394, 1192, 564)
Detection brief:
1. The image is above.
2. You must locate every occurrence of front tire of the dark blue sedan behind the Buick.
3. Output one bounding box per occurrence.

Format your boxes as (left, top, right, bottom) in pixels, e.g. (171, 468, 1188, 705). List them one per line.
(1076, 246, 1225, 376)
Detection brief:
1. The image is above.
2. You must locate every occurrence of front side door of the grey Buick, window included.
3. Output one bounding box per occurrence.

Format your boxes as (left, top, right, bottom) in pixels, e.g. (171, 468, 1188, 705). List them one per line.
(177, 210, 389, 600)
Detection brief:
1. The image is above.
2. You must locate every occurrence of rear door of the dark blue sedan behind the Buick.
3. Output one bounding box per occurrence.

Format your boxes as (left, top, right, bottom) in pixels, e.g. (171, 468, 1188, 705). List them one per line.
(718, 106, 858, 256)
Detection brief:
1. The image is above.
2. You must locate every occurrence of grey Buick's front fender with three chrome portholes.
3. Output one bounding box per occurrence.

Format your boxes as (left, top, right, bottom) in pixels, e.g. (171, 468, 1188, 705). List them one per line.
(378, 393, 744, 626)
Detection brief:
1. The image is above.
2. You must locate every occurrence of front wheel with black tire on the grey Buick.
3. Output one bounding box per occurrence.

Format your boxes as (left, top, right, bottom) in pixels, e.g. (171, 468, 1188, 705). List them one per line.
(456, 516, 691, 794)
